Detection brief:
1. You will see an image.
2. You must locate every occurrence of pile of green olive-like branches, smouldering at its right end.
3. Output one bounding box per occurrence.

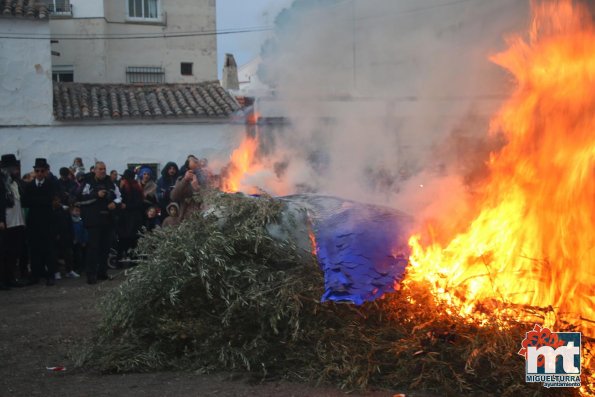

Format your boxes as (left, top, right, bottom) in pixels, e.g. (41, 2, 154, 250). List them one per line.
(77, 190, 588, 396)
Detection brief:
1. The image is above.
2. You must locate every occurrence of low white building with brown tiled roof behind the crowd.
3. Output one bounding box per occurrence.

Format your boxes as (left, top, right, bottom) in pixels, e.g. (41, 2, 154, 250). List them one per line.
(0, 78, 245, 172)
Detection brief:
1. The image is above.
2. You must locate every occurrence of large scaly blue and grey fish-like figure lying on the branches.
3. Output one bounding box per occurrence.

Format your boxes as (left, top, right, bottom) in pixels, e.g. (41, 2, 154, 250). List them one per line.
(269, 193, 413, 305)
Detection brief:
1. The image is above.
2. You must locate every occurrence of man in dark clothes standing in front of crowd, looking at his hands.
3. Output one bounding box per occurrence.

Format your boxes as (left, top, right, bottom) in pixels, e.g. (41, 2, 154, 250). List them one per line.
(79, 161, 122, 284)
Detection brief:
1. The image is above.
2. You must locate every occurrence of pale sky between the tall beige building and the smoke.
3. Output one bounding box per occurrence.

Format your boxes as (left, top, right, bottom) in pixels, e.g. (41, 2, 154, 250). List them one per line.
(217, 0, 291, 76)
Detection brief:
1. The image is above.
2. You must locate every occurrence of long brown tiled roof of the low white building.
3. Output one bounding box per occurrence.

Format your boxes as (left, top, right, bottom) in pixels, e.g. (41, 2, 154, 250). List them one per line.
(54, 81, 240, 120)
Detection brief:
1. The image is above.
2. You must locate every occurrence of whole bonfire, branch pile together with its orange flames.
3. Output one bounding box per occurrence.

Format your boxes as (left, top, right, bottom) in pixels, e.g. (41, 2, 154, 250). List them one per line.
(78, 1, 595, 396)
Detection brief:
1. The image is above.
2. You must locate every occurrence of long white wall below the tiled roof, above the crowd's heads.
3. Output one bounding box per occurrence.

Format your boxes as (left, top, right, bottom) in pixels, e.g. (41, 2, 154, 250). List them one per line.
(0, 124, 245, 174)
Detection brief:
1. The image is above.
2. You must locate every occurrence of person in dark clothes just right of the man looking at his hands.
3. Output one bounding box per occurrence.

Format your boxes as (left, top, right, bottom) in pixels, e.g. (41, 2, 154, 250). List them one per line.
(118, 170, 144, 262)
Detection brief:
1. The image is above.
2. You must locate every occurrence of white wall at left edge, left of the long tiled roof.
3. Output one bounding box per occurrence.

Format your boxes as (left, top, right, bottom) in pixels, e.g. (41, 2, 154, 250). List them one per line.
(0, 18, 53, 126)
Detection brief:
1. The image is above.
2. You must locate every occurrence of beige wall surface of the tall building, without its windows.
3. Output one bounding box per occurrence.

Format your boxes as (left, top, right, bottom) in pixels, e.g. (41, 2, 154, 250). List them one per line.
(50, 0, 217, 83)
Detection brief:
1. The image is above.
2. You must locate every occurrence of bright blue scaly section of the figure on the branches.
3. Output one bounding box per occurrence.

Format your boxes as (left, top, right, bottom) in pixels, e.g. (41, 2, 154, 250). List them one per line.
(313, 202, 411, 305)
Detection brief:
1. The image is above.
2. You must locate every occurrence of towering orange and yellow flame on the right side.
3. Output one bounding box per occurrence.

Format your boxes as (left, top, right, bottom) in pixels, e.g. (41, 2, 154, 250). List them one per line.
(408, 0, 595, 335)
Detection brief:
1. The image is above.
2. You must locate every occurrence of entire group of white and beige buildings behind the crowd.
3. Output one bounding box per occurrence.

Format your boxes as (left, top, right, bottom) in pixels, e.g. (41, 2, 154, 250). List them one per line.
(0, 0, 245, 173)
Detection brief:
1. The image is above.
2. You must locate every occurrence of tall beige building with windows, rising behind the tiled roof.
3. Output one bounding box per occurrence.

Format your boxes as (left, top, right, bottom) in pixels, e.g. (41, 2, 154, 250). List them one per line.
(46, 0, 217, 84)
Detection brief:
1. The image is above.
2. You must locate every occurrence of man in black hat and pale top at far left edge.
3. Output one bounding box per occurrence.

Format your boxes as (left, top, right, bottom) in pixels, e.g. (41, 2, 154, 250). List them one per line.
(0, 154, 27, 289)
